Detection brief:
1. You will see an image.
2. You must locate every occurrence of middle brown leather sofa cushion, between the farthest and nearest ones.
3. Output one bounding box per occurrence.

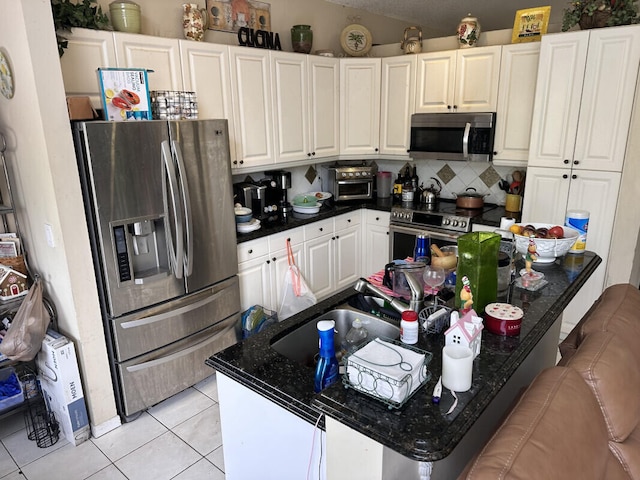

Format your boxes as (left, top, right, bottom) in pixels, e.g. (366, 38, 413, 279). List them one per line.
(567, 332, 640, 442)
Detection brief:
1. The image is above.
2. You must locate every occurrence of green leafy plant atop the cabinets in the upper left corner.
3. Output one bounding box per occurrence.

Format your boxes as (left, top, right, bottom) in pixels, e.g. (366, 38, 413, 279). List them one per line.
(51, 0, 110, 56)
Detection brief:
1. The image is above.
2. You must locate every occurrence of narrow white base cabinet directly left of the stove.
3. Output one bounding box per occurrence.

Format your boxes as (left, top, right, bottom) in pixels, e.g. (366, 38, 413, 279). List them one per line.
(362, 210, 391, 277)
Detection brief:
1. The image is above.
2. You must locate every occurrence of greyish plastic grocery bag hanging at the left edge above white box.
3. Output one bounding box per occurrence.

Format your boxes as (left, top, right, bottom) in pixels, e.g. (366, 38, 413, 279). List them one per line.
(0, 276, 51, 362)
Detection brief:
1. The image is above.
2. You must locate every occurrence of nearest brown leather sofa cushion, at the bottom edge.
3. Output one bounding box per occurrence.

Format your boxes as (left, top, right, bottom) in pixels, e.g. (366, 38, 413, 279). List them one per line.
(466, 367, 629, 480)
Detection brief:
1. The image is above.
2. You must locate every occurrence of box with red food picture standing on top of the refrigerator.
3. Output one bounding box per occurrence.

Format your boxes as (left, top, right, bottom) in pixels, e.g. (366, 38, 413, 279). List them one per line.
(98, 68, 152, 121)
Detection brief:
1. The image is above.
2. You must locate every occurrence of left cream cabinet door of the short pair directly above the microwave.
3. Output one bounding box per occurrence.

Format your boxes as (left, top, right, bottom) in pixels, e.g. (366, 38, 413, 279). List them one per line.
(415, 50, 457, 113)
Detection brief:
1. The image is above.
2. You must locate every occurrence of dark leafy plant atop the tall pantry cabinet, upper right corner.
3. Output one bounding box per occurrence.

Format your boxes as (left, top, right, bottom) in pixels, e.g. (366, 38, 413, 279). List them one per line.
(562, 0, 640, 32)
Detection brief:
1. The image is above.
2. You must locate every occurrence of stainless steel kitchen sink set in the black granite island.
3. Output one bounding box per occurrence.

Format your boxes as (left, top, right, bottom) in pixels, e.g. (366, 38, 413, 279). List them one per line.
(271, 308, 400, 368)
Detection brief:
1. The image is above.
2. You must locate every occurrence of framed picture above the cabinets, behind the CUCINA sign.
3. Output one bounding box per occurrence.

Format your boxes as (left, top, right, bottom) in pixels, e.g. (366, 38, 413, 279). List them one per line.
(207, 0, 271, 32)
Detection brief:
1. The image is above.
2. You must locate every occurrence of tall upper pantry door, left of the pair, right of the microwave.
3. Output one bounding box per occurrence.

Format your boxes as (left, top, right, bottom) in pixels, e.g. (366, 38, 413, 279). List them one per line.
(529, 31, 589, 167)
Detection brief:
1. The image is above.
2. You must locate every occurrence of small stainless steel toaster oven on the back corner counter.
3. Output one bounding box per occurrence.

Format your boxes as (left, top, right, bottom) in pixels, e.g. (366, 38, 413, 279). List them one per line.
(322, 162, 376, 201)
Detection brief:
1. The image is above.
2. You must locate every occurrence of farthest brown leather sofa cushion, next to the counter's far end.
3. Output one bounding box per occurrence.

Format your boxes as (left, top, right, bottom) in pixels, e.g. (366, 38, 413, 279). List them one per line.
(559, 283, 640, 364)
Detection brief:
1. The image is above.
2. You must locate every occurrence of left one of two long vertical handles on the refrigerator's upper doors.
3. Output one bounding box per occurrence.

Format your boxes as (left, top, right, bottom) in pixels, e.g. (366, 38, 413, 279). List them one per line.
(161, 140, 184, 278)
